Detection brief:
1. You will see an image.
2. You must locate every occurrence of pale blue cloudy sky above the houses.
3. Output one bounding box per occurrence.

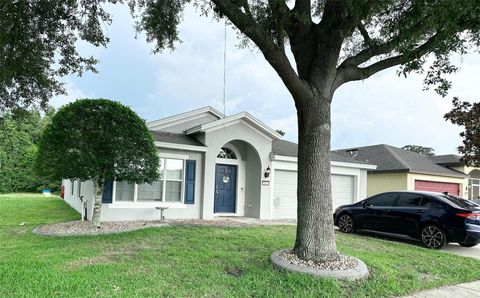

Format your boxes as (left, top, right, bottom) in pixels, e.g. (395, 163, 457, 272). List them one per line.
(51, 5, 480, 154)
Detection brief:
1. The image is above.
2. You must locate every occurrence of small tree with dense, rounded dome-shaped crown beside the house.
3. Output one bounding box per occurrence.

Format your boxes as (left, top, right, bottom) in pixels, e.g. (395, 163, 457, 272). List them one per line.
(36, 99, 159, 227)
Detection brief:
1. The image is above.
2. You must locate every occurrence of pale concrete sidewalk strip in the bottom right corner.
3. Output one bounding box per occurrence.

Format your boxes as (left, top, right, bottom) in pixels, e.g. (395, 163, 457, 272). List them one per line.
(403, 281, 480, 298)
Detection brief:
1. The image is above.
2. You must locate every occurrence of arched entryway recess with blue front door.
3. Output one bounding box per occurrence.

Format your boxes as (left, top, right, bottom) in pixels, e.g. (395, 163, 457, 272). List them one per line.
(213, 140, 261, 217)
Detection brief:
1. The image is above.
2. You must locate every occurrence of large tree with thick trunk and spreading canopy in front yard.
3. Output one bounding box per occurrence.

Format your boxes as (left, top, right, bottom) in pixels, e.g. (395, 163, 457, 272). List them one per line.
(0, 0, 480, 261)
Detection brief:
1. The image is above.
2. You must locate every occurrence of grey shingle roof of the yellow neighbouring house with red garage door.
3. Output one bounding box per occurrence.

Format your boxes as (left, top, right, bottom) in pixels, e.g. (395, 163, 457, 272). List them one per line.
(334, 144, 466, 178)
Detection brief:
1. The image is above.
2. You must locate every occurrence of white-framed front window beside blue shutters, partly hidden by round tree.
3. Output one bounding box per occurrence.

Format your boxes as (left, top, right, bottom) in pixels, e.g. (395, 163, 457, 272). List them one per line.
(119, 158, 184, 202)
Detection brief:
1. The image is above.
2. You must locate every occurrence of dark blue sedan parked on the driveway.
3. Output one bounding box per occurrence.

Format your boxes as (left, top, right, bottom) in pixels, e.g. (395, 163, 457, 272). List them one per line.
(333, 191, 480, 249)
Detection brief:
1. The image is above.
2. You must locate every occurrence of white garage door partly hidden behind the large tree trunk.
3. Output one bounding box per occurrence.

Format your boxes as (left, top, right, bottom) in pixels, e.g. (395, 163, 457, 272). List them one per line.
(273, 170, 354, 219)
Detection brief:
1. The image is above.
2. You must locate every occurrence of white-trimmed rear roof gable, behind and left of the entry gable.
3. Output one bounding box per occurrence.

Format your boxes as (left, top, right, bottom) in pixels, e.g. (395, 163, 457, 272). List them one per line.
(147, 106, 223, 133)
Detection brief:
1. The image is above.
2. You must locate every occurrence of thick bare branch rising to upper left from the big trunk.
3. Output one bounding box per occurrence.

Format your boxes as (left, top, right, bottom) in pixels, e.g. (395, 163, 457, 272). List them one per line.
(211, 0, 310, 98)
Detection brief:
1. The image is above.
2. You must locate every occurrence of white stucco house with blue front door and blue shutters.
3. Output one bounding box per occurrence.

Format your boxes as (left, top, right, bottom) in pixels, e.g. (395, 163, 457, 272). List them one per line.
(63, 107, 376, 221)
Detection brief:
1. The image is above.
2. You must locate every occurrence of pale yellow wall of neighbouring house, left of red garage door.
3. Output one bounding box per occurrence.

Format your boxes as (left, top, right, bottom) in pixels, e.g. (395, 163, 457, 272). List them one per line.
(367, 173, 407, 197)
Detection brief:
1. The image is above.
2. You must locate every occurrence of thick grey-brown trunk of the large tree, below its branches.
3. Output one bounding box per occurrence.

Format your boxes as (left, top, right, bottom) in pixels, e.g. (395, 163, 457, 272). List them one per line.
(294, 95, 338, 262)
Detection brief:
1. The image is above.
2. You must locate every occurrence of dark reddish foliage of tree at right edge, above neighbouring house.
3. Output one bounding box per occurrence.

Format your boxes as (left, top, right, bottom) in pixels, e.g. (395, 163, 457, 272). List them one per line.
(444, 97, 480, 167)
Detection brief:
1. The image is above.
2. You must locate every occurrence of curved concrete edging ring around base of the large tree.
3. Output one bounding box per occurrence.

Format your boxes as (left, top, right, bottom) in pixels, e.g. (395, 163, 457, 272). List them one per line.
(270, 249, 370, 280)
